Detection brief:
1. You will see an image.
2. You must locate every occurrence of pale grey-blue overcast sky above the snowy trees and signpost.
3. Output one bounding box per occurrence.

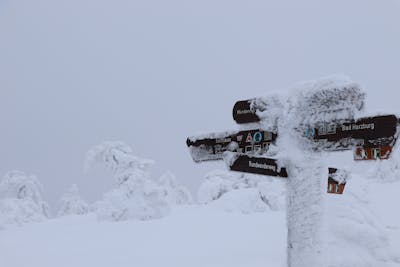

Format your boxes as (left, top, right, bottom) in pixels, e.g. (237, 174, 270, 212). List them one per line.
(0, 0, 400, 209)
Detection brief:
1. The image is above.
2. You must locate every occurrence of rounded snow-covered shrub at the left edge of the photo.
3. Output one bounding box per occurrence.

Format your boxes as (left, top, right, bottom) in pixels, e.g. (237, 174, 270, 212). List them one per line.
(0, 171, 49, 224)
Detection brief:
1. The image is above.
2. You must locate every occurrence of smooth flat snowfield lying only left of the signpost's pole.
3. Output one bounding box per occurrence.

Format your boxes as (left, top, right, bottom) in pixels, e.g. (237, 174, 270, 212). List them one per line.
(0, 206, 286, 267)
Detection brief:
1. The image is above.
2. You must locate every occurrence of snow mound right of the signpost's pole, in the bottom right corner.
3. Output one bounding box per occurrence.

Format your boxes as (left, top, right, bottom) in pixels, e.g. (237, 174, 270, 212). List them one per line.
(322, 175, 400, 267)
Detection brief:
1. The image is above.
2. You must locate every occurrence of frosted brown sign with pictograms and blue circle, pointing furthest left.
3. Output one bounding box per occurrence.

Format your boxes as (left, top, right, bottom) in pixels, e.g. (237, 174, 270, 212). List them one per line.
(186, 129, 277, 162)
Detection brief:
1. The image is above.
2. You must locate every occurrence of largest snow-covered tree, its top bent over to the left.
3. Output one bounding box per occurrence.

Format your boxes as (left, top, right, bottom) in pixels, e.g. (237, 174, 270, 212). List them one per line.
(85, 142, 169, 221)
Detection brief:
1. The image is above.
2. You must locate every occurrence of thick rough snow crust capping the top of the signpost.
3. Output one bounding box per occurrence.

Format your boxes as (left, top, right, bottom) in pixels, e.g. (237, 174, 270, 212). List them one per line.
(240, 75, 365, 131)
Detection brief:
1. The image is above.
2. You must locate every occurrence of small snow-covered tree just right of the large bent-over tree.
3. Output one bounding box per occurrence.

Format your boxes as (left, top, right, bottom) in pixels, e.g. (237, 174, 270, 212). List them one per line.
(158, 171, 192, 205)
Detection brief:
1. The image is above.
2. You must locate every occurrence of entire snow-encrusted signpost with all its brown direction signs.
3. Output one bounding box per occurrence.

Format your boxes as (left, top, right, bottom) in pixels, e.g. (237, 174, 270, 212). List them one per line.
(187, 77, 398, 267)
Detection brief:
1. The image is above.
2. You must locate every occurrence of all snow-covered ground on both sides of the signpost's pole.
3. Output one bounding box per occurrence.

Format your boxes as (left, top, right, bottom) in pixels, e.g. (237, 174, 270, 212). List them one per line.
(0, 171, 400, 267)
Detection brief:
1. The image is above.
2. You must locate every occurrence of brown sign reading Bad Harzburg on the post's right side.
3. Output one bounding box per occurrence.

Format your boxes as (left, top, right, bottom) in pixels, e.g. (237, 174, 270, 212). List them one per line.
(307, 115, 398, 150)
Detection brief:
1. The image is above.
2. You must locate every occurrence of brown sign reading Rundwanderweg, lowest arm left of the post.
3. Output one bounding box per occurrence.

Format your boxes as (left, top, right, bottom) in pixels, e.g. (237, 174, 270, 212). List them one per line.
(230, 154, 288, 178)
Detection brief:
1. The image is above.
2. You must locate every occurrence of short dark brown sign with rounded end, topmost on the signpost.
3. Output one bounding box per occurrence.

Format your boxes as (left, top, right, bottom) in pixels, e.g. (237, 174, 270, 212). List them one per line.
(233, 99, 264, 124)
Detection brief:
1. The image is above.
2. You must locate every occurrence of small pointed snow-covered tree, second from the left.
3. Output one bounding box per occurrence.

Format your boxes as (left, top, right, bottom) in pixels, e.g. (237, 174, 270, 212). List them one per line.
(58, 184, 89, 216)
